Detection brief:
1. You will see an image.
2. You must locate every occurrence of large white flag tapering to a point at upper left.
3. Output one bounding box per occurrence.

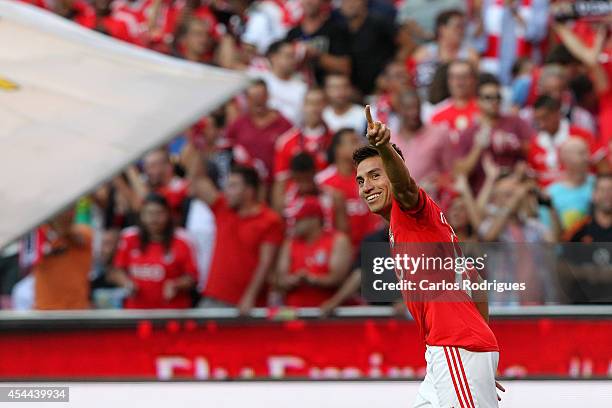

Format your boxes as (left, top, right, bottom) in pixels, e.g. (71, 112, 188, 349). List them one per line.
(0, 0, 246, 248)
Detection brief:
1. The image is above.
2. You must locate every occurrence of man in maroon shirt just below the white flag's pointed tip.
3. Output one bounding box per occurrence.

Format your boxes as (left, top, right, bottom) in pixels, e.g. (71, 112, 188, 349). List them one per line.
(227, 79, 292, 179)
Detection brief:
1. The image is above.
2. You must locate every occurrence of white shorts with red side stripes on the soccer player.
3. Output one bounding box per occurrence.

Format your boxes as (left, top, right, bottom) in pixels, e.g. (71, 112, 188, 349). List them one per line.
(413, 346, 499, 408)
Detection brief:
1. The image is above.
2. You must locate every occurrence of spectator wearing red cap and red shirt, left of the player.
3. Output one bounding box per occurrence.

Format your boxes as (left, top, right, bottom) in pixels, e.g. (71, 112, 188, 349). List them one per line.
(277, 197, 352, 307)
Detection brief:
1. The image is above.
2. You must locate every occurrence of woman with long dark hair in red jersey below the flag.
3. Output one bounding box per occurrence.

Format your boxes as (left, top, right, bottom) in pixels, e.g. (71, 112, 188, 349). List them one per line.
(109, 193, 198, 309)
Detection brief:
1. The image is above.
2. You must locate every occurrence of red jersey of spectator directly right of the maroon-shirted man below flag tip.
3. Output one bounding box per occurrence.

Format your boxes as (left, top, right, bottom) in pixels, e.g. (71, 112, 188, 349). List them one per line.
(274, 126, 332, 180)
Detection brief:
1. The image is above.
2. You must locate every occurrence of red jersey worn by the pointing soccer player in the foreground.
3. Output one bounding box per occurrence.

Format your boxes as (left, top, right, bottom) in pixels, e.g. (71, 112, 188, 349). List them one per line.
(389, 189, 498, 352)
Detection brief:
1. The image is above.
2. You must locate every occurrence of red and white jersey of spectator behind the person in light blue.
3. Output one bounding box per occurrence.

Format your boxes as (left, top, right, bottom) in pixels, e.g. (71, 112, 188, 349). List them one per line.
(527, 119, 605, 187)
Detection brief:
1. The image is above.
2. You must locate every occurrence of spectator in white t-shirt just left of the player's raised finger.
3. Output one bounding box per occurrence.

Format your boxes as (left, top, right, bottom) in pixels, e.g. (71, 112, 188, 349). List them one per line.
(323, 74, 366, 135)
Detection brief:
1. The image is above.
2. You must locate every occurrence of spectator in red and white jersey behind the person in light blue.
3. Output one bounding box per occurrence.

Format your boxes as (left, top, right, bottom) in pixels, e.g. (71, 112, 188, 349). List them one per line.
(528, 95, 605, 187)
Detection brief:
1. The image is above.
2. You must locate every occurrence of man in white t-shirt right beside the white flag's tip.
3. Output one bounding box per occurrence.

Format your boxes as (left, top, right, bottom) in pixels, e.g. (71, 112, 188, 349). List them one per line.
(252, 40, 308, 126)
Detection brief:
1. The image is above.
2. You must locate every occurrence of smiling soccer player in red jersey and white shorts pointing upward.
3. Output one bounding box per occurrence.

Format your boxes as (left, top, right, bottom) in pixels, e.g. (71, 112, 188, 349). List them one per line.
(353, 106, 505, 408)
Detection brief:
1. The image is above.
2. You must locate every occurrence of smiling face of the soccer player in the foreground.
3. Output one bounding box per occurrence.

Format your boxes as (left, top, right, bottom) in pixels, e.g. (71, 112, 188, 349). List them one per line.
(357, 157, 391, 214)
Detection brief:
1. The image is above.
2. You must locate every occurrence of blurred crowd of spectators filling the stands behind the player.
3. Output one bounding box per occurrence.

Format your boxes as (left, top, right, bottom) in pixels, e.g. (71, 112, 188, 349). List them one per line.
(0, 0, 612, 314)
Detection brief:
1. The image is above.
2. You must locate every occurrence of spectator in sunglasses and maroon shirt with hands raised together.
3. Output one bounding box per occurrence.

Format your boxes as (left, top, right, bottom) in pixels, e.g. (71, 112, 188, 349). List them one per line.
(451, 74, 533, 191)
